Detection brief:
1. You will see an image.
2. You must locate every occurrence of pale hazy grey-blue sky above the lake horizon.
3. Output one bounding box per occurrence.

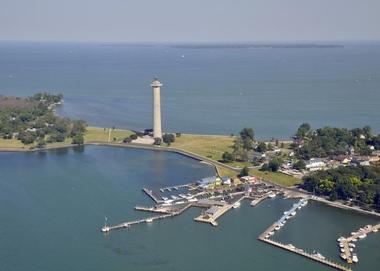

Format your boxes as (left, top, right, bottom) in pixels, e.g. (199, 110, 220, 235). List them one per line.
(0, 0, 380, 42)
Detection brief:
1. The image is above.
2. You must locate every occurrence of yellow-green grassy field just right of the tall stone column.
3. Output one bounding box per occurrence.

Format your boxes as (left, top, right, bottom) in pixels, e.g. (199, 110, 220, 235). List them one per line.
(171, 134, 235, 161)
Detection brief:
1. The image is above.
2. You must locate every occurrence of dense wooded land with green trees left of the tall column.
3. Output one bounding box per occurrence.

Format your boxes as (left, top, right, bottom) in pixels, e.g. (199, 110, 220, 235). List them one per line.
(0, 93, 87, 148)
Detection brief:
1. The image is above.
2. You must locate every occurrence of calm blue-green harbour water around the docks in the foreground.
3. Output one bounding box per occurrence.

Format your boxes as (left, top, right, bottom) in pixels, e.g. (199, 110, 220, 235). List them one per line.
(0, 146, 380, 271)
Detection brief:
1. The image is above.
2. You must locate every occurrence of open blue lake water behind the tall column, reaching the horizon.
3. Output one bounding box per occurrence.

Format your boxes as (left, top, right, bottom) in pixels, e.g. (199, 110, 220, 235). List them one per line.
(0, 42, 380, 138)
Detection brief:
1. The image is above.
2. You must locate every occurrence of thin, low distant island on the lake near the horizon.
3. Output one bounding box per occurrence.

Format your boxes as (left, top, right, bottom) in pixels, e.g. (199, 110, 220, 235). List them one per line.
(171, 43, 344, 49)
